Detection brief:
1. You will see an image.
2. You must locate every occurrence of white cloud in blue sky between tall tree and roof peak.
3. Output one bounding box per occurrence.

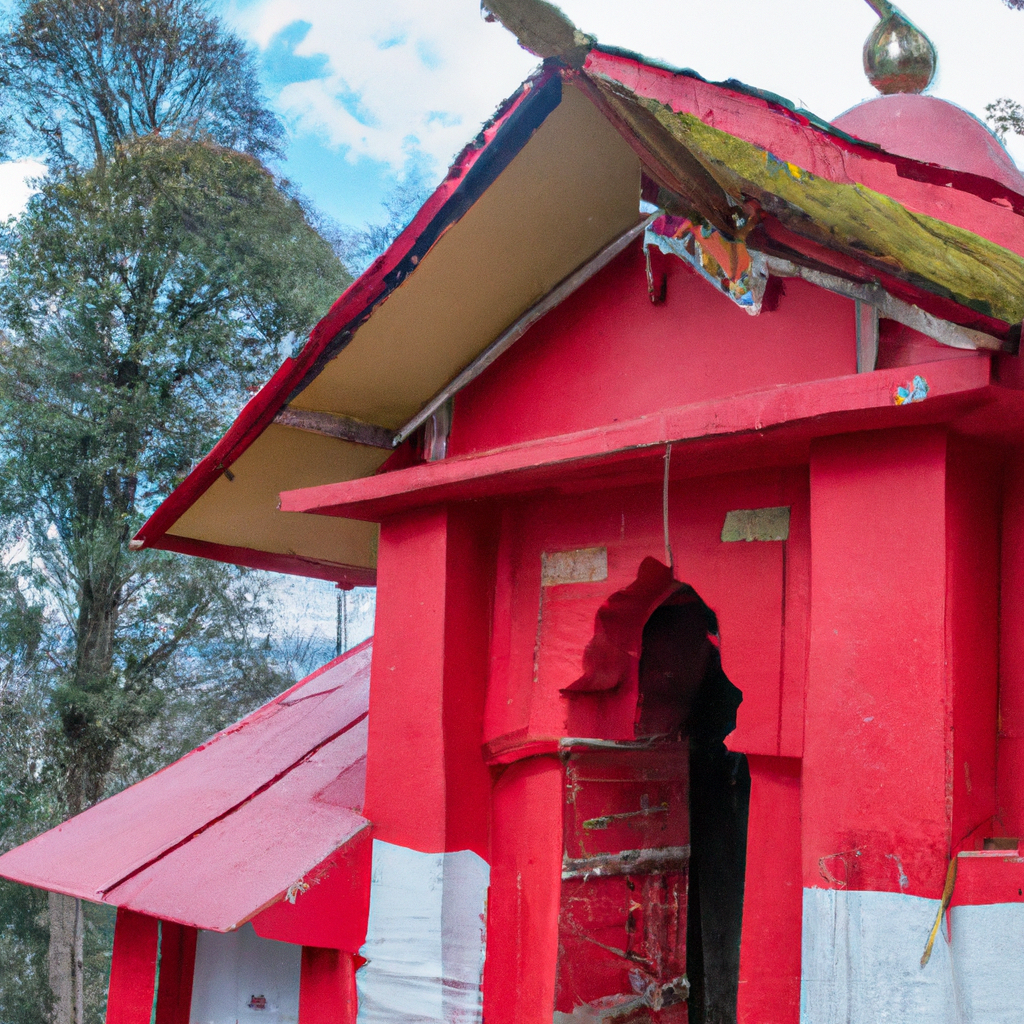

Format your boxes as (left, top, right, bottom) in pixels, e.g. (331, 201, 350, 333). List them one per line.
(232, 0, 537, 169)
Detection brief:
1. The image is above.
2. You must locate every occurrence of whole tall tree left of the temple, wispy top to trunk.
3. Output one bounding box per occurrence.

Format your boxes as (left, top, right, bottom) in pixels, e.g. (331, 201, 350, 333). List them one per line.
(0, 0, 349, 1024)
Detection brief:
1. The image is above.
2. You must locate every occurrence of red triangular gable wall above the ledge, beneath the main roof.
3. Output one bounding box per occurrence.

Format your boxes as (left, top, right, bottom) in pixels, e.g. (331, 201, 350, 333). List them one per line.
(449, 245, 857, 455)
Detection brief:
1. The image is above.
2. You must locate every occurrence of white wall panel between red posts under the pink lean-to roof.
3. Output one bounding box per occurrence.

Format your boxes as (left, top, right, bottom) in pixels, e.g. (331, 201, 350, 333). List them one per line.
(188, 925, 302, 1024)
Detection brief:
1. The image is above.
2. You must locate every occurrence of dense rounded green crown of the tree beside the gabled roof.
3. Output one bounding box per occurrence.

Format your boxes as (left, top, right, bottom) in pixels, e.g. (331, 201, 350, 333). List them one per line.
(0, 138, 348, 520)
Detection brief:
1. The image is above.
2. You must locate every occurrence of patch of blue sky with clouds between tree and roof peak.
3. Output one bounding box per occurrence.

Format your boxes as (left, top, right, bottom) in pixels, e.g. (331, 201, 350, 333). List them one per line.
(222, 0, 536, 226)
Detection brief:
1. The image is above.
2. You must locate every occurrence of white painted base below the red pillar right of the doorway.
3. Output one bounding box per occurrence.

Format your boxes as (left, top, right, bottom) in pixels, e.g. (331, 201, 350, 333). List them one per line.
(800, 889, 1024, 1024)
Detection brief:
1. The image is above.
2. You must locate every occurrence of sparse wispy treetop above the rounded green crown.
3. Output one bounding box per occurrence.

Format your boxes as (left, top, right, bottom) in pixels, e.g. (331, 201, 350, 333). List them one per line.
(0, 0, 284, 165)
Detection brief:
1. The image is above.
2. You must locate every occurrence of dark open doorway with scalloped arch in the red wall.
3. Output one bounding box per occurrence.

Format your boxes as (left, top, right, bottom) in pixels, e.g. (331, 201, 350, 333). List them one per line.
(636, 587, 751, 1024)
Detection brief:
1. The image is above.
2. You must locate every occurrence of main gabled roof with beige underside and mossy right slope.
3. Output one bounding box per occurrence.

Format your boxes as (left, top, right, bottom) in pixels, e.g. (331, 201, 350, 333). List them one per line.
(136, 36, 1024, 584)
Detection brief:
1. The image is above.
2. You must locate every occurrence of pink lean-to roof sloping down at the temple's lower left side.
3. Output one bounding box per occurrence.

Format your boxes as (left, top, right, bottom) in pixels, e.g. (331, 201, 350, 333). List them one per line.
(0, 641, 371, 932)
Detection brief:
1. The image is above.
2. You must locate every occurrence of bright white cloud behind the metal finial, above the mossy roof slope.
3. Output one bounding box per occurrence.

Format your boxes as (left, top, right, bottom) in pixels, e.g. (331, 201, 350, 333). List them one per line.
(562, 0, 1024, 118)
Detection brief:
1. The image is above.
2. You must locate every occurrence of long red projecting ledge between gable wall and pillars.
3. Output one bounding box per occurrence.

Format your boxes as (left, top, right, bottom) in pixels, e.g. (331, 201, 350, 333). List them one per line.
(282, 352, 1007, 522)
